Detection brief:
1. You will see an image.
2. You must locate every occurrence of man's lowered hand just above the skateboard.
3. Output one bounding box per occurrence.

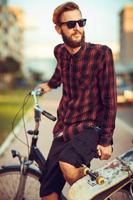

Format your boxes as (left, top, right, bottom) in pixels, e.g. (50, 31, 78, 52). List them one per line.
(97, 145, 112, 160)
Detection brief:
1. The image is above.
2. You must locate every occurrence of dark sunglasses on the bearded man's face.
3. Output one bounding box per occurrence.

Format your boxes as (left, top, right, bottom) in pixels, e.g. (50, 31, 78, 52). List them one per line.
(60, 19, 86, 29)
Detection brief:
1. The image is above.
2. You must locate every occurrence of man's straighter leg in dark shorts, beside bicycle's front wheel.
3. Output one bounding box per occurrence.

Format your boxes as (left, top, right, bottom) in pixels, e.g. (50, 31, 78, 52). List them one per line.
(40, 138, 66, 200)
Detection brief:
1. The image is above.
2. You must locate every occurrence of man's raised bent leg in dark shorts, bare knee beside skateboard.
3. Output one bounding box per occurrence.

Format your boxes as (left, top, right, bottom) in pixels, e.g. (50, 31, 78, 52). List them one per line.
(59, 128, 99, 185)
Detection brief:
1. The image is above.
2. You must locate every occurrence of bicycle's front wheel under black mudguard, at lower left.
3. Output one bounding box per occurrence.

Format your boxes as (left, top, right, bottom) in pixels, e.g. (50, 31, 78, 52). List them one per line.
(0, 165, 40, 200)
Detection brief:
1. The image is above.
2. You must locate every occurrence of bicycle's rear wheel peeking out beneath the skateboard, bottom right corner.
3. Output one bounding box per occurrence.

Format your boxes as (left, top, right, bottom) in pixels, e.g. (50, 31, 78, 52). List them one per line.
(108, 189, 133, 200)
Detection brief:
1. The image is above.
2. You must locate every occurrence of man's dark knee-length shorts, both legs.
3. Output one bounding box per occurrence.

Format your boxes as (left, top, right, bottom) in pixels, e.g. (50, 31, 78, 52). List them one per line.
(40, 128, 99, 197)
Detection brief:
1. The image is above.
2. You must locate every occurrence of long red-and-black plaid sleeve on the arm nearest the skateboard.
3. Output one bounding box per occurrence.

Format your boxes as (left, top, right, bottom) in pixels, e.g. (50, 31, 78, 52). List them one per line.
(99, 47, 117, 145)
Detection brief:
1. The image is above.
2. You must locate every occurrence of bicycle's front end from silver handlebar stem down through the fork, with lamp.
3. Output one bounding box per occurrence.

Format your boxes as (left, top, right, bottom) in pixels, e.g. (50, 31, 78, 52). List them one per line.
(7, 90, 56, 200)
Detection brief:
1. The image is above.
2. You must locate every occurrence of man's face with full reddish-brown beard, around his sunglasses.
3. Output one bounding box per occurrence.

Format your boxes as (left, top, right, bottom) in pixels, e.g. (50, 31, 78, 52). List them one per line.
(60, 10, 85, 48)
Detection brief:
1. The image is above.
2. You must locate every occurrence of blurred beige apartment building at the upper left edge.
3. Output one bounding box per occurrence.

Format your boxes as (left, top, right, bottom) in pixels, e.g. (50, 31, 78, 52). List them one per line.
(0, 4, 24, 64)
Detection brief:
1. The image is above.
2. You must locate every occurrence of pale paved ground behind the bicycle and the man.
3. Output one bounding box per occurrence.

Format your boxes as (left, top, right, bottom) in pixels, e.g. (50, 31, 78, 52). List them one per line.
(0, 91, 133, 197)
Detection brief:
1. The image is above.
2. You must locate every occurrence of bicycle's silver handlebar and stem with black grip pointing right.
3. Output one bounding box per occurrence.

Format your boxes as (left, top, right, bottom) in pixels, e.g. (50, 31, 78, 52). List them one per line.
(29, 88, 56, 121)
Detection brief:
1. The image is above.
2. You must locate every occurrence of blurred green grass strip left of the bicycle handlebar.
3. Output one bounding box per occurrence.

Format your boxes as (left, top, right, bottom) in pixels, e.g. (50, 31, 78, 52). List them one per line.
(0, 89, 32, 144)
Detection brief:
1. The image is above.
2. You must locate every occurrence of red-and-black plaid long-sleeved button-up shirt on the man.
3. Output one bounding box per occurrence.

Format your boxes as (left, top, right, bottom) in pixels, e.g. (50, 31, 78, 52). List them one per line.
(48, 42, 116, 145)
